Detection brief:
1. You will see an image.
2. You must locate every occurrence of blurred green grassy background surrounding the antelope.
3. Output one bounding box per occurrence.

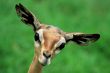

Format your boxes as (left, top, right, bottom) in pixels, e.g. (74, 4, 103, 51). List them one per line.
(0, 0, 110, 73)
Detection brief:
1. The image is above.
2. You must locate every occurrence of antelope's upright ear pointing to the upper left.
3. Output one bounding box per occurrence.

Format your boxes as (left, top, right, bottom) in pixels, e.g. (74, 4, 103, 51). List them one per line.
(15, 4, 40, 30)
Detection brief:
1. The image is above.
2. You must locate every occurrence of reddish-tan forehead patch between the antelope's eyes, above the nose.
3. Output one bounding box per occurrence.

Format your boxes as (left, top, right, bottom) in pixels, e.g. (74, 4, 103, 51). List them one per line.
(43, 30, 61, 49)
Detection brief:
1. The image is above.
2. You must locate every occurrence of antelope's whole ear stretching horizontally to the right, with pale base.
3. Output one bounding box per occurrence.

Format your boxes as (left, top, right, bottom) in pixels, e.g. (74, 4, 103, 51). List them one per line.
(65, 33, 100, 45)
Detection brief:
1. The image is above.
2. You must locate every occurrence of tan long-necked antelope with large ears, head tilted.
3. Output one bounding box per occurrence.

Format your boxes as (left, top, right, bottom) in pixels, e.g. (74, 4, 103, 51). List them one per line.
(15, 4, 100, 73)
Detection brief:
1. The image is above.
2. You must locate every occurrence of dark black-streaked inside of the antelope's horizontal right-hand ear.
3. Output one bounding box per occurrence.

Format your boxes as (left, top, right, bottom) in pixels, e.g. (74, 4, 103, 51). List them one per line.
(72, 34, 100, 45)
